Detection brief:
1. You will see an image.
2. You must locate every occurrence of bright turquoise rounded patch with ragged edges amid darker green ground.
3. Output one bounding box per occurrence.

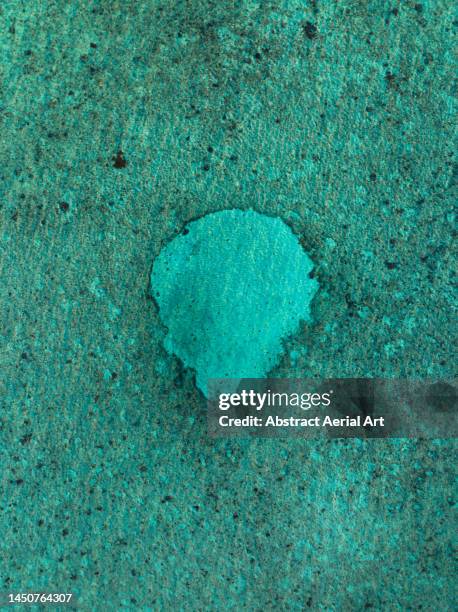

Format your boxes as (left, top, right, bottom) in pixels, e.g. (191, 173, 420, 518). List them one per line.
(151, 210, 318, 395)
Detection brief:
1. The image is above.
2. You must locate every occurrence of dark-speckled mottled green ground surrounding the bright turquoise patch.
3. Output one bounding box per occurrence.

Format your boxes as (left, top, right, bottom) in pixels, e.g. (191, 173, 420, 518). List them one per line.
(0, 0, 456, 611)
